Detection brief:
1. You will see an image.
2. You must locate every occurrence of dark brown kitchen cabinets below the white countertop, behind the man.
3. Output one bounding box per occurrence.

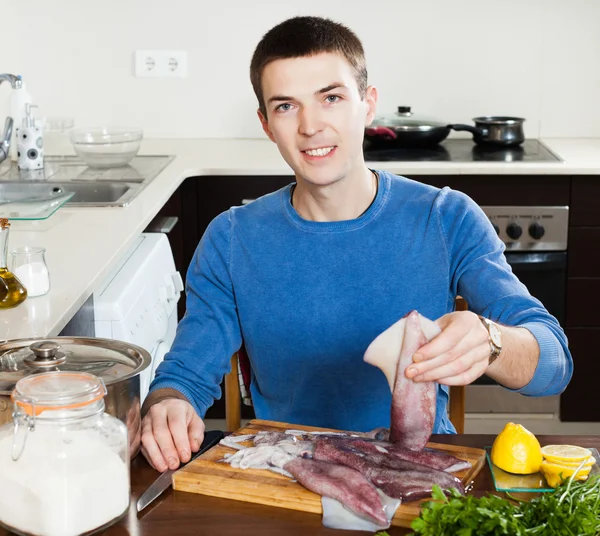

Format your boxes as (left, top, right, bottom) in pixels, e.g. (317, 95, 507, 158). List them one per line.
(161, 175, 600, 421)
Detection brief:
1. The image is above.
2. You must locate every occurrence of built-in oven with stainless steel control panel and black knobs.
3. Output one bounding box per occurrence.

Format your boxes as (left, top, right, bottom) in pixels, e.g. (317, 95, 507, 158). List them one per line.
(466, 206, 569, 415)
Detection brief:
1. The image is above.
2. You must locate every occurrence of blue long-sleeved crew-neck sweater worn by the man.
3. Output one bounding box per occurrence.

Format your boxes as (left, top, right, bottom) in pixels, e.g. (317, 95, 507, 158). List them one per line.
(151, 171, 573, 433)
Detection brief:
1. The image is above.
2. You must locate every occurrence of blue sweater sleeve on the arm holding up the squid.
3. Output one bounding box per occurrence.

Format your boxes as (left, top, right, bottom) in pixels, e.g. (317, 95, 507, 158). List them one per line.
(436, 188, 573, 396)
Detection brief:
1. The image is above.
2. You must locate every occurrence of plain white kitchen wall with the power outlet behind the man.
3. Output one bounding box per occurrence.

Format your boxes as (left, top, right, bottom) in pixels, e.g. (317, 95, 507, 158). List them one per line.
(0, 0, 600, 138)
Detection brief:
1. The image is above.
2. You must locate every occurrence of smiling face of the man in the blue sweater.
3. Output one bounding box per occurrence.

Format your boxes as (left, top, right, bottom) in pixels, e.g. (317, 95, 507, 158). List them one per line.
(258, 53, 377, 186)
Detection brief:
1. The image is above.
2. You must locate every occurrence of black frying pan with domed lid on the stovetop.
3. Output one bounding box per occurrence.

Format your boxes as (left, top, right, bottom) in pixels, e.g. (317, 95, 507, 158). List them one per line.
(365, 106, 451, 149)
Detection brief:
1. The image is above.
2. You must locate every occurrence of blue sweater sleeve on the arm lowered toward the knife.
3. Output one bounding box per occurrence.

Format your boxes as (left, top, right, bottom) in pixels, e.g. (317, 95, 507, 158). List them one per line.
(150, 212, 242, 418)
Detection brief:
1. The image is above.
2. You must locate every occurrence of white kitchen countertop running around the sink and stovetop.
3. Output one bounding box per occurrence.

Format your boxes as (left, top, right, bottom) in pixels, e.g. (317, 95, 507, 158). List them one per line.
(0, 139, 600, 340)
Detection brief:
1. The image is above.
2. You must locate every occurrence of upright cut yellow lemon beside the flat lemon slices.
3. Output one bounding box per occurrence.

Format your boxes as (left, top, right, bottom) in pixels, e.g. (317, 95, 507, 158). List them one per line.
(490, 422, 542, 475)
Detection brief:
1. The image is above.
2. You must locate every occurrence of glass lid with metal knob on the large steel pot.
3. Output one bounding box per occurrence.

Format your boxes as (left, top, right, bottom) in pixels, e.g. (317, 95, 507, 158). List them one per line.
(0, 337, 151, 395)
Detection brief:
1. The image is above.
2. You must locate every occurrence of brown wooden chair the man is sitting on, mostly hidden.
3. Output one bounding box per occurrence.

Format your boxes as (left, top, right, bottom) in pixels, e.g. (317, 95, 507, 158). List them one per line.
(225, 296, 467, 434)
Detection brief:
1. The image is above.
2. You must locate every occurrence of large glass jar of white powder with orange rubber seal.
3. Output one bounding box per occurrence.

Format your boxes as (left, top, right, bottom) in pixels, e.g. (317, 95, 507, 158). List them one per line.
(0, 371, 130, 536)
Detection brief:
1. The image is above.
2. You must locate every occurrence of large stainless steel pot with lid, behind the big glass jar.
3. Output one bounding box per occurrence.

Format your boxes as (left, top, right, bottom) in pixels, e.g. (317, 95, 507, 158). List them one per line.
(0, 337, 152, 457)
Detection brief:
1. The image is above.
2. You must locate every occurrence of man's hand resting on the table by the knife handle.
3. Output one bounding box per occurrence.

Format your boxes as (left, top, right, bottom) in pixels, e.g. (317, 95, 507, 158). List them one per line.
(142, 397, 204, 473)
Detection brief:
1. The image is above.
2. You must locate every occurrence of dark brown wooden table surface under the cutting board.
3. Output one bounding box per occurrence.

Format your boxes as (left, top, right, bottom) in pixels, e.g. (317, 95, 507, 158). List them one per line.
(0, 435, 600, 536)
